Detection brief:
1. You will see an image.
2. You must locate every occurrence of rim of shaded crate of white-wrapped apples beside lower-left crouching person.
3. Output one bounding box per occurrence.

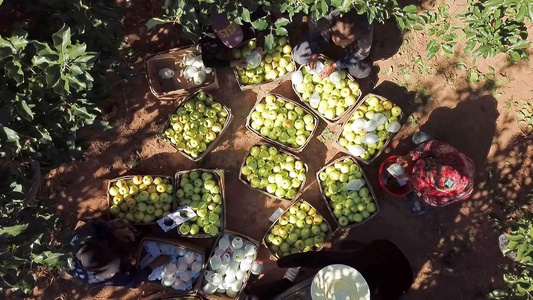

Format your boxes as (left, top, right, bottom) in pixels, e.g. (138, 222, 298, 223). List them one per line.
(135, 237, 207, 296)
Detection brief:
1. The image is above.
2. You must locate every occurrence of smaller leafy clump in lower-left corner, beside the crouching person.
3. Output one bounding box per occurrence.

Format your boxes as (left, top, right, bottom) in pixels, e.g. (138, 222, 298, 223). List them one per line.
(0, 170, 71, 294)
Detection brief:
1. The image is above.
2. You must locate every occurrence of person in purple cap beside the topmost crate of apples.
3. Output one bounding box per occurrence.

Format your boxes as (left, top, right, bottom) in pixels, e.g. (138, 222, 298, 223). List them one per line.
(200, 10, 264, 68)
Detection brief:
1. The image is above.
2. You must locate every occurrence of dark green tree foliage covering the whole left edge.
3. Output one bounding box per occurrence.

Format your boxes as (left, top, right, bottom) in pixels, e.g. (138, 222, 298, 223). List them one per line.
(0, 0, 121, 294)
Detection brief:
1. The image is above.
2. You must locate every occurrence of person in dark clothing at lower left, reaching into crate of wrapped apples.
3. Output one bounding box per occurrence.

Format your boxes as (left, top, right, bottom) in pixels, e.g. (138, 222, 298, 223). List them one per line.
(67, 220, 170, 287)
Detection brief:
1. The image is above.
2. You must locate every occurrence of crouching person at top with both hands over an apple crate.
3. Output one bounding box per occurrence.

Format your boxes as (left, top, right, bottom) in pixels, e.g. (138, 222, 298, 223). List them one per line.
(293, 9, 373, 78)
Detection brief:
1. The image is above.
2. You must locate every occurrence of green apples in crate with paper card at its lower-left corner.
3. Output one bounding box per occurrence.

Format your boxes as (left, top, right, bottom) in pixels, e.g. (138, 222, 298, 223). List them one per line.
(176, 171, 223, 236)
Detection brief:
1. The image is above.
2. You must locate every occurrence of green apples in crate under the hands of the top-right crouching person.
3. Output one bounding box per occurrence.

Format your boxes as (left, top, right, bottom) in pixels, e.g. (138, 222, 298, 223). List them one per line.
(293, 61, 360, 121)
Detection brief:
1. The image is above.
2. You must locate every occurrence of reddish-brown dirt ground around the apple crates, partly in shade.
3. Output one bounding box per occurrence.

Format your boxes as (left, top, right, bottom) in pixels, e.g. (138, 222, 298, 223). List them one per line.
(36, 0, 533, 300)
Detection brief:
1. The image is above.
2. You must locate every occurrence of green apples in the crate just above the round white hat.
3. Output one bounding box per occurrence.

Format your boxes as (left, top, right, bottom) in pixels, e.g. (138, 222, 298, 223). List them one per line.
(265, 202, 329, 258)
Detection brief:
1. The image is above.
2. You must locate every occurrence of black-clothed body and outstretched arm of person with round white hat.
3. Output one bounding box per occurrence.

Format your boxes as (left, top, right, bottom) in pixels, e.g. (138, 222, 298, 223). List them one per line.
(245, 240, 413, 300)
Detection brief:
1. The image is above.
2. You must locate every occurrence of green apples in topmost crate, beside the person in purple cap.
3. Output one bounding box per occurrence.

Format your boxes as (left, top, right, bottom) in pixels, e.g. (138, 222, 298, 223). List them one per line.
(232, 37, 295, 85)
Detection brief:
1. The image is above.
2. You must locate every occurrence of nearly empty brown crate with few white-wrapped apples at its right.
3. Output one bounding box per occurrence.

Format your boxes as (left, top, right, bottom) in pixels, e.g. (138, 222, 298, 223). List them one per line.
(145, 47, 219, 100)
